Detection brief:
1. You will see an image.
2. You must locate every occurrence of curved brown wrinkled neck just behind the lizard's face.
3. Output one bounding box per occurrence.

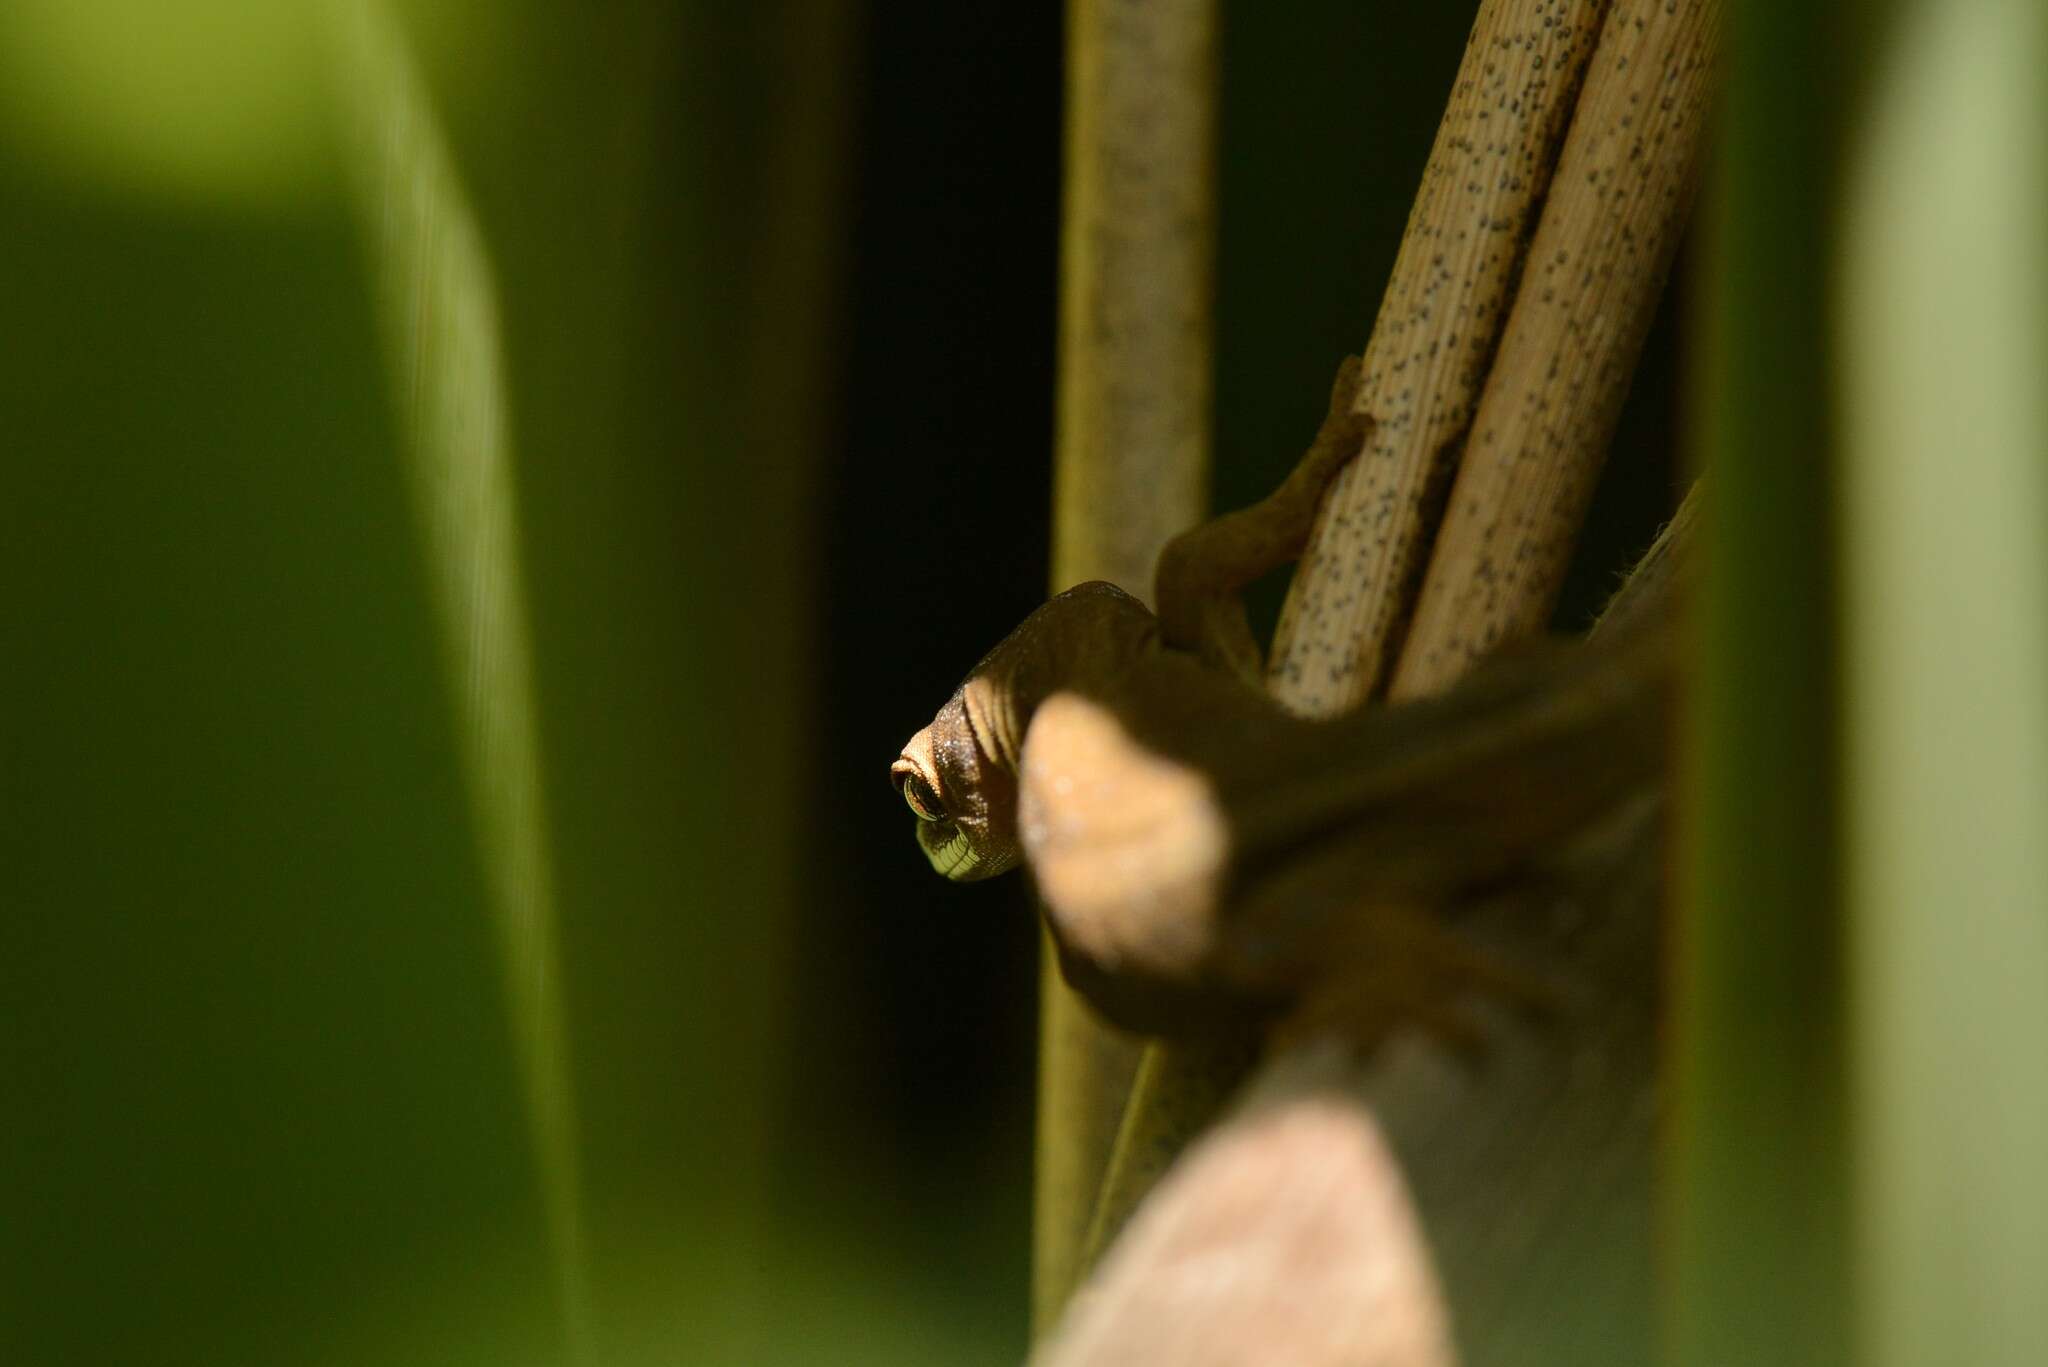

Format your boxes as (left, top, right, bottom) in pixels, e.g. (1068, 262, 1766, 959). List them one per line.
(961, 580, 1159, 775)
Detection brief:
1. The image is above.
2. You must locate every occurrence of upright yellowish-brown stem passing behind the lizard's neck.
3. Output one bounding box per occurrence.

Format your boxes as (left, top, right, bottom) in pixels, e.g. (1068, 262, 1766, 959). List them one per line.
(1032, 0, 1217, 1330)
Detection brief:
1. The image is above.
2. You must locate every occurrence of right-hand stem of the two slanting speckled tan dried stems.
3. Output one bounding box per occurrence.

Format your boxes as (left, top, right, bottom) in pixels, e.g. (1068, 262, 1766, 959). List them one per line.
(1389, 0, 1720, 701)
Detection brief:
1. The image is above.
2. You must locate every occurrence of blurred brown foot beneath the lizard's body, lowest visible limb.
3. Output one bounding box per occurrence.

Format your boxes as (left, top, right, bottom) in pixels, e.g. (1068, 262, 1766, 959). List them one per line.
(1274, 908, 1563, 1064)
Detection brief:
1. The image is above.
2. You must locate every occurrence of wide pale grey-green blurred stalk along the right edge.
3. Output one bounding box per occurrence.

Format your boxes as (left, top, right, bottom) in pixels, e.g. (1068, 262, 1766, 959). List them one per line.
(1839, 0, 2048, 1367)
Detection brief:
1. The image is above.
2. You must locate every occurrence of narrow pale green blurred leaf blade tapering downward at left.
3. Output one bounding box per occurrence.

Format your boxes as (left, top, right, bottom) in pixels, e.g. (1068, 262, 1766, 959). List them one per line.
(332, 0, 590, 1361)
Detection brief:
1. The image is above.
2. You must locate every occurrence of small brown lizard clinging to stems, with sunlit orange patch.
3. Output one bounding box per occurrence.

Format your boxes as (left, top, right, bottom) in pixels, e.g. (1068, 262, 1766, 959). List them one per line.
(889, 357, 1675, 1041)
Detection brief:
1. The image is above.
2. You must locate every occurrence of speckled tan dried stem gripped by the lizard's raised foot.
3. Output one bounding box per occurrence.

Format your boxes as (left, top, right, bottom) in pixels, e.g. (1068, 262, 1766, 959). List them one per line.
(1268, 0, 1606, 717)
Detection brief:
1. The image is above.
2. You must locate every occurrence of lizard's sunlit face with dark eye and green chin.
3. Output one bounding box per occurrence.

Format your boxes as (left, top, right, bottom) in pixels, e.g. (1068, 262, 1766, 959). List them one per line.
(889, 678, 1020, 883)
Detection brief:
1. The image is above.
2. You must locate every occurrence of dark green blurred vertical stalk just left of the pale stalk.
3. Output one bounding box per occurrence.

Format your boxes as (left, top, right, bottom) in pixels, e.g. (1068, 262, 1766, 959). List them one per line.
(1669, 0, 1845, 1367)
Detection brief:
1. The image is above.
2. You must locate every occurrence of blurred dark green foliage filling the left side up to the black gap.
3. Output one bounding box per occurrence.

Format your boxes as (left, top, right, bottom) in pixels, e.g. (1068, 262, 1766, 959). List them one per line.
(0, 0, 1014, 1363)
